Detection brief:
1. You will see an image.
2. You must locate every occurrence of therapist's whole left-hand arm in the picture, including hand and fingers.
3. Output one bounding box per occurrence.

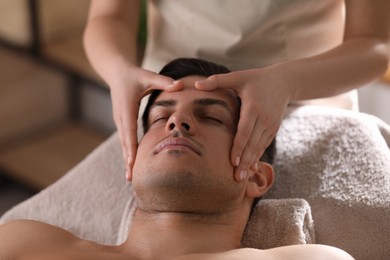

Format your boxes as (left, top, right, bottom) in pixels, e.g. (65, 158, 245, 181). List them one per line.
(84, 0, 178, 180)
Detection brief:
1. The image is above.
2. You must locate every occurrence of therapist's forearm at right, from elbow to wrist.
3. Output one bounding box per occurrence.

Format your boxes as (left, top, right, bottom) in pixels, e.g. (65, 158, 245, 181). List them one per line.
(280, 38, 389, 101)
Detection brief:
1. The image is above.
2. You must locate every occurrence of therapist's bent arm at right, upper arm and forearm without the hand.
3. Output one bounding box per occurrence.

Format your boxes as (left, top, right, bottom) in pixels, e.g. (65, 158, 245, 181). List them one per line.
(284, 0, 390, 100)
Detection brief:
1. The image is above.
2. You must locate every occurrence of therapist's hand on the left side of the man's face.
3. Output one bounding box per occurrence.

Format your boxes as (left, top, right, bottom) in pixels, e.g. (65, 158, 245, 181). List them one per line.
(110, 66, 182, 181)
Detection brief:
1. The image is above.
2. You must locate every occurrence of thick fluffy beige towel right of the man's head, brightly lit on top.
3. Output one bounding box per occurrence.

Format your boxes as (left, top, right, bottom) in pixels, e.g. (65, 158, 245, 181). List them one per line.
(265, 107, 390, 260)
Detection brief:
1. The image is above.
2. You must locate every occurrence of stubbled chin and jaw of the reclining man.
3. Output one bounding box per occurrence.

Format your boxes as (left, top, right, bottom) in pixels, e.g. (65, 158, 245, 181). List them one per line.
(133, 163, 241, 213)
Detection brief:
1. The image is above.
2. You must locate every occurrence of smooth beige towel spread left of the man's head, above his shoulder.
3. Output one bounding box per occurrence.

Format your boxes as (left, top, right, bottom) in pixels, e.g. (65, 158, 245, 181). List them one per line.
(0, 134, 133, 245)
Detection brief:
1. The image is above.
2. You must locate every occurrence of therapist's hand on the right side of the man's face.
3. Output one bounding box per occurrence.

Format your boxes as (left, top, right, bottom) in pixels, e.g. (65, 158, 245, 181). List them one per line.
(195, 67, 290, 181)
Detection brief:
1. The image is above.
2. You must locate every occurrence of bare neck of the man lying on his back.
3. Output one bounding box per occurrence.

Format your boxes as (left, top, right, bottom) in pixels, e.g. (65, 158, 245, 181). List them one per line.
(122, 209, 245, 259)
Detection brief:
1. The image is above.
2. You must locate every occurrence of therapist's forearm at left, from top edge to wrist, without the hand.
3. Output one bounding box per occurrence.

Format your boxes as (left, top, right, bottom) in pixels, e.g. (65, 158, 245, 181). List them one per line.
(84, 0, 140, 80)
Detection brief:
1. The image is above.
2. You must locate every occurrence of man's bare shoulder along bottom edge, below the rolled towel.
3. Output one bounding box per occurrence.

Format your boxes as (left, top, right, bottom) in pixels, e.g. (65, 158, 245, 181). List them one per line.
(177, 245, 354, 260)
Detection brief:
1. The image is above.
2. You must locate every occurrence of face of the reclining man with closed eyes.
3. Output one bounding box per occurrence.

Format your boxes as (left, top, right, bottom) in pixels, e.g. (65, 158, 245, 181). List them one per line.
(133, 76, 244, 212)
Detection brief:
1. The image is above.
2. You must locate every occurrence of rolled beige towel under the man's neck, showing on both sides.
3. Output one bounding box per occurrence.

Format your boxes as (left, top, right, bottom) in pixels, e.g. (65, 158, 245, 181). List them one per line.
(117, 199, 315, 249)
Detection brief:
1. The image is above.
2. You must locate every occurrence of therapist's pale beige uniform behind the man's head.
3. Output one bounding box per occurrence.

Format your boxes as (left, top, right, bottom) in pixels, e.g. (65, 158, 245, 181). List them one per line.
(142, 0, 357, 138)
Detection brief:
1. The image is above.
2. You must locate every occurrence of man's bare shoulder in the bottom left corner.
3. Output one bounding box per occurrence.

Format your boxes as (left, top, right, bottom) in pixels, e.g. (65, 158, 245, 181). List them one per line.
(0, 220, 79, 259)
